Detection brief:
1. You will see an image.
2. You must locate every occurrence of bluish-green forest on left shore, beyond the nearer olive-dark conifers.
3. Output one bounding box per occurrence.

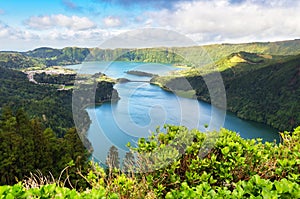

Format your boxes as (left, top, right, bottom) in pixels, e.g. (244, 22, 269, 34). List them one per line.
(0, 67, 117, 137)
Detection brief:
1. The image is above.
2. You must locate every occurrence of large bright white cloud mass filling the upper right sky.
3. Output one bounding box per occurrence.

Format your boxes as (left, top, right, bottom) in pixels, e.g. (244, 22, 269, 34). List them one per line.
(146, 0, 300, 42)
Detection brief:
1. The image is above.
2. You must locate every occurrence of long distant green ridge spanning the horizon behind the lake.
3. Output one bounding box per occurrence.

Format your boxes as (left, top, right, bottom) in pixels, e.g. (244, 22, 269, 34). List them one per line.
(0, 39, 300, 68)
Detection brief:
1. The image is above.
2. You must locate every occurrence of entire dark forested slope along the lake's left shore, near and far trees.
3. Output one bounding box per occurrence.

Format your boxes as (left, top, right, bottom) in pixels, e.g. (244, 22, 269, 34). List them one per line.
(0, 67, 118, 186)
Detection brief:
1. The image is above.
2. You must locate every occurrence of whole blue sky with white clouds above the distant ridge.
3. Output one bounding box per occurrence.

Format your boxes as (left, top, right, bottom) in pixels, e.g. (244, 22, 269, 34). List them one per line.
(0, 0, 300, 51)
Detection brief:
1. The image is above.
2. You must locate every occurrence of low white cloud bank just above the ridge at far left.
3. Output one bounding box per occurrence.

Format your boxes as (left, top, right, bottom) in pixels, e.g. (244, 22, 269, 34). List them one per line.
(0, 21, 111, 51)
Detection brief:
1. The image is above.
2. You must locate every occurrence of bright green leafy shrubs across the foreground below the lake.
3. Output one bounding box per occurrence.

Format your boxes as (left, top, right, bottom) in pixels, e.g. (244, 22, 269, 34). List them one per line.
(0, 125, 300, 198)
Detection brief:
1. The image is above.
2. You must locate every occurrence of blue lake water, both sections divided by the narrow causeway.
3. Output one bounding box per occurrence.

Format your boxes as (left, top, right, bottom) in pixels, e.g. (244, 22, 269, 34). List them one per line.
(67, 62, 279, 162)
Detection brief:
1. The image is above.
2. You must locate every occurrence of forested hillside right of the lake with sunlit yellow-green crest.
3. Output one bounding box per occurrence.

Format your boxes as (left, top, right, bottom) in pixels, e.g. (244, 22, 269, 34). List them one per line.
(151, 52, 300, 130)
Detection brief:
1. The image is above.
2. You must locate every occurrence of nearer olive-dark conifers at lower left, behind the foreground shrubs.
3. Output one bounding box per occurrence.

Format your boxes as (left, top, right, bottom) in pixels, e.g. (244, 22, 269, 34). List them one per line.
(0, 108, 89, 185)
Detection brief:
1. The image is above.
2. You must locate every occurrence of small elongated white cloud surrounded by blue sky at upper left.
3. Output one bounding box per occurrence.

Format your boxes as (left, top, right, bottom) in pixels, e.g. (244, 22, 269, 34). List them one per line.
(25, 14, 96, 30)
